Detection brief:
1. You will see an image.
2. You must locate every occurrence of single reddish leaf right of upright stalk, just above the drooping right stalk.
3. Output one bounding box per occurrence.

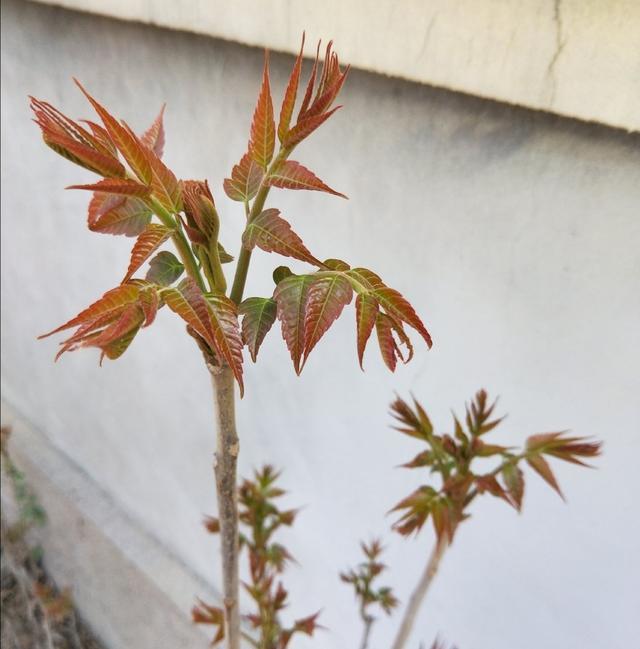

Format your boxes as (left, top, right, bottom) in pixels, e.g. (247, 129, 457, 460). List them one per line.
(242, 208, 322, 266)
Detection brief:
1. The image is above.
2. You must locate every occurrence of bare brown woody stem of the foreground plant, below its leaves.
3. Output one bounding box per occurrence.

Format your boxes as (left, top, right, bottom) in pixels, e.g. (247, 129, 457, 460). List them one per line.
(210, 366, 240, 649)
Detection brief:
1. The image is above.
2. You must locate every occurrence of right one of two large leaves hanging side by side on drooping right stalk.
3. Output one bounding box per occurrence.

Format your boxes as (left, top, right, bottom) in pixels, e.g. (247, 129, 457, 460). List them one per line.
(301, 273, 353, 369)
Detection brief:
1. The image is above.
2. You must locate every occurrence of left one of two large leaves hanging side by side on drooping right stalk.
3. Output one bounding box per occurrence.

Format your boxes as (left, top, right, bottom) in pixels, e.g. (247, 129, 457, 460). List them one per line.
(273, 275, 313, 374)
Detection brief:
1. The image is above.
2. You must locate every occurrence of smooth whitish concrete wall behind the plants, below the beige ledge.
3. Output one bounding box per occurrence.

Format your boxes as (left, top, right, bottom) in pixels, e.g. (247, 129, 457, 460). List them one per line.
(2, 0, 640, 649)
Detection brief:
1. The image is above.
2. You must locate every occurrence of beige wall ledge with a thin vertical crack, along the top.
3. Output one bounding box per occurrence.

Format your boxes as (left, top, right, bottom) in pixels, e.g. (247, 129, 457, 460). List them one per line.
(28, 0, 640, 130)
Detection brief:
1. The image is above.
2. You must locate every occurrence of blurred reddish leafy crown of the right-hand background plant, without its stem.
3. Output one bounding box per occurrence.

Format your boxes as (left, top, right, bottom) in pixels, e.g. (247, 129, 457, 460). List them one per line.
(391, 390, 600, 543)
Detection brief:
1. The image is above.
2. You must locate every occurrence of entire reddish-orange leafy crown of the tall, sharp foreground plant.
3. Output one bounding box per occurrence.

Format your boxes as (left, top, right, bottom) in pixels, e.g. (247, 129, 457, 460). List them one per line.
(31, 39, 431, 391)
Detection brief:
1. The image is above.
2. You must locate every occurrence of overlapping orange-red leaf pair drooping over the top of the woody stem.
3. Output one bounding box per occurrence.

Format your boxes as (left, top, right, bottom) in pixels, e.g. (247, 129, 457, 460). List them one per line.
(162, 277, 244, 394)
